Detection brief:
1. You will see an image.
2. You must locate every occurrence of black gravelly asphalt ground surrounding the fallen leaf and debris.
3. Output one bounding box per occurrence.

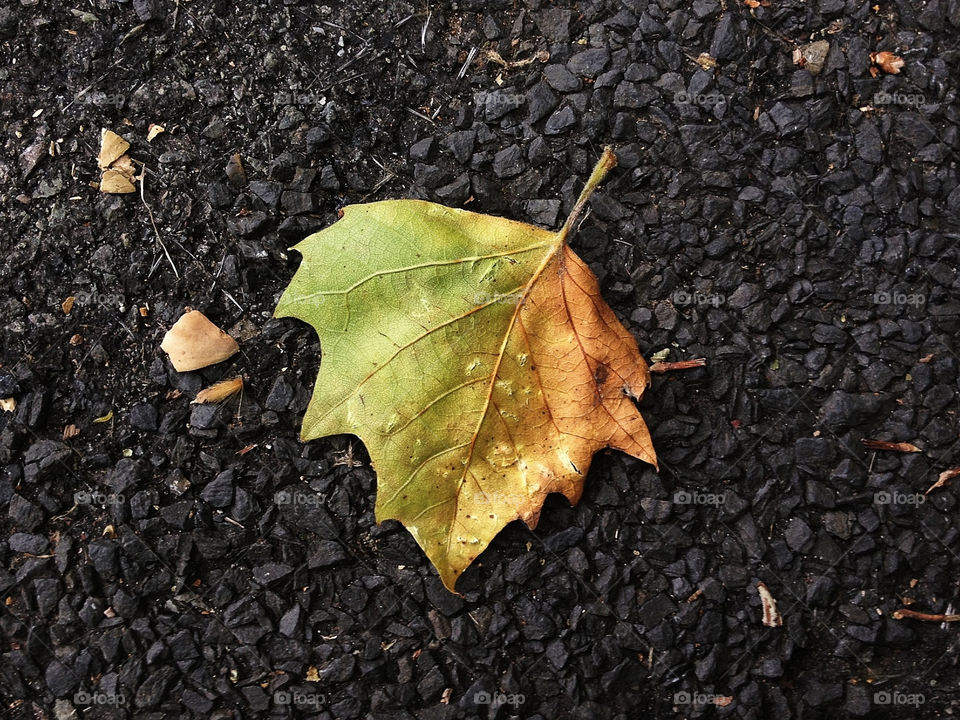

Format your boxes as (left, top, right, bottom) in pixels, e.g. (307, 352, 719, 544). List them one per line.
(0, 0, 960, 720)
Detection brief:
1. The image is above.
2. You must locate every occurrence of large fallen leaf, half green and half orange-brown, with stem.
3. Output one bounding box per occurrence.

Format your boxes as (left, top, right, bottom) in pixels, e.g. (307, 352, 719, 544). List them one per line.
(275, 148, 656, 591)
